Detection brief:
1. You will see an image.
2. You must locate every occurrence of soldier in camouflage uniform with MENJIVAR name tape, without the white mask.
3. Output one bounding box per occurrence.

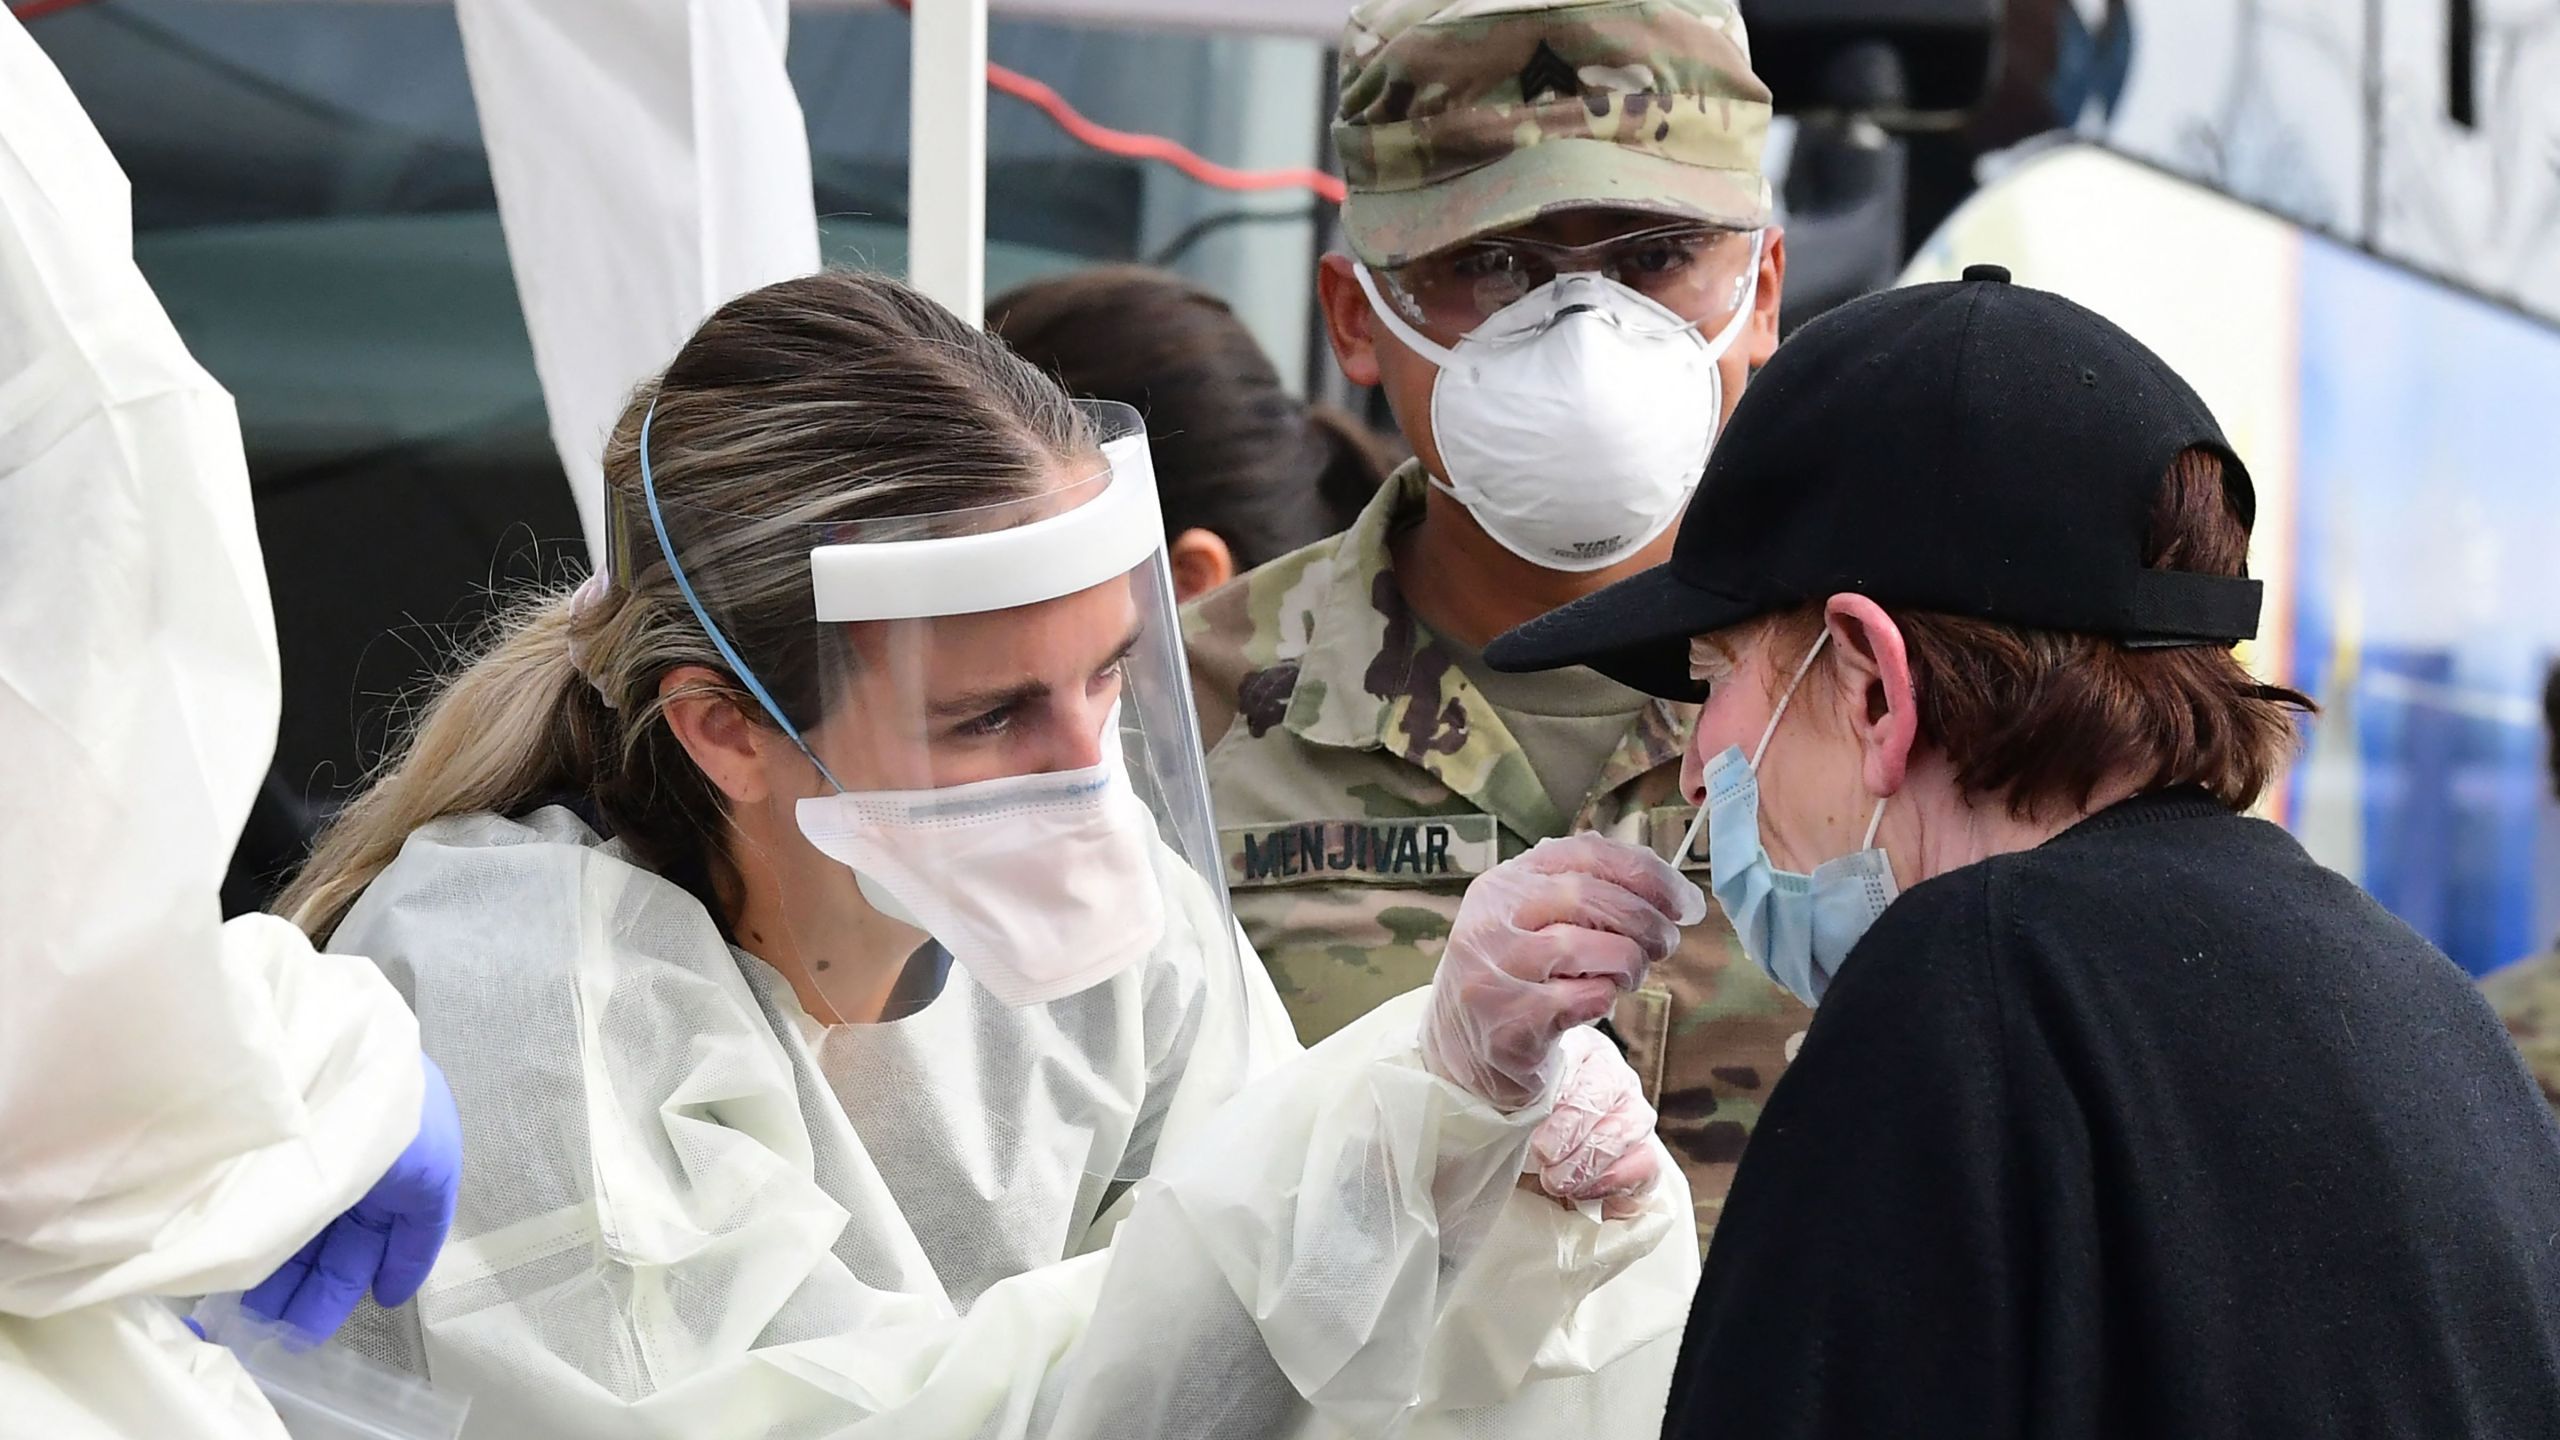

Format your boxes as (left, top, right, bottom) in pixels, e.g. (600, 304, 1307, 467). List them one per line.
(1185, 0, 1810, 1243)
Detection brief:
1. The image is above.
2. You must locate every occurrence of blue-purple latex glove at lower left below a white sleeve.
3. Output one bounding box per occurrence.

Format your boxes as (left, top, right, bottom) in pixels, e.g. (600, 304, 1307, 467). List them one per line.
(241, 1056, 463, 1345)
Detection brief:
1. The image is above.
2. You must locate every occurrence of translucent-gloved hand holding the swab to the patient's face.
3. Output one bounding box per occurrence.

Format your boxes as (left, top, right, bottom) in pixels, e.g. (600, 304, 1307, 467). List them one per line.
(1423, 835, 1708, 1109)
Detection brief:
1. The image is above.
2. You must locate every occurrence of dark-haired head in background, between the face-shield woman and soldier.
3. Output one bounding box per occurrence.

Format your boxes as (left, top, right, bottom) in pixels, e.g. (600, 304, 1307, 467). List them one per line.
(986, 266, 1385, 600)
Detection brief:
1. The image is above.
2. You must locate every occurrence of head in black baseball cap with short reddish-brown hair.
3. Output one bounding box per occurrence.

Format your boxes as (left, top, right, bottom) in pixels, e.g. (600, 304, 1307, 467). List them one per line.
(1487, 266, 2309, 884)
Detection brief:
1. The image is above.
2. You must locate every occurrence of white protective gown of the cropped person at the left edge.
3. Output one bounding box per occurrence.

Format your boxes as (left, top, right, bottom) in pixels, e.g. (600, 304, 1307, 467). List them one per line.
(0, 15, 422, 1440)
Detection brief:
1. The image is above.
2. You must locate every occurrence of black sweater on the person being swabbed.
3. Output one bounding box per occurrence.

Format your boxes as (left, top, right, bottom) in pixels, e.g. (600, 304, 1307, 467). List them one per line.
(1664, 792, 2560, 1440)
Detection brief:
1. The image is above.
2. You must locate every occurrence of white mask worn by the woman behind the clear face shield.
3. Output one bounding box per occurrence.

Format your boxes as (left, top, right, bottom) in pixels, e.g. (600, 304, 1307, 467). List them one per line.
(799, 715, 1165, 1007)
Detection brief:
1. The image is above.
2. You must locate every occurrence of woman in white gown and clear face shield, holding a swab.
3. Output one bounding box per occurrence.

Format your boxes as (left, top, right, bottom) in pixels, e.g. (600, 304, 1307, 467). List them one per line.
(284, 274, 1702, 1440)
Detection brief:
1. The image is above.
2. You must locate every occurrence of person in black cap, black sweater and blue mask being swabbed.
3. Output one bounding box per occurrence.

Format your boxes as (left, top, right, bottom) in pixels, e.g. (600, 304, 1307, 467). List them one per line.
(1487, 266, 2560, 1440)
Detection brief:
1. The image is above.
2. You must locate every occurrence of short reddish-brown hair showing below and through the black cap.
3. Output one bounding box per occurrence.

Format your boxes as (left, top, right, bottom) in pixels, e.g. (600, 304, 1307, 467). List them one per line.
(1774, 448, 2314, 817)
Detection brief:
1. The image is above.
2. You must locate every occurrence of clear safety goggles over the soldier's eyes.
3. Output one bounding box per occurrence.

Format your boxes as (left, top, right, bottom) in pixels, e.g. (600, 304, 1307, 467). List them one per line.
(1370, 223, 1764, 343)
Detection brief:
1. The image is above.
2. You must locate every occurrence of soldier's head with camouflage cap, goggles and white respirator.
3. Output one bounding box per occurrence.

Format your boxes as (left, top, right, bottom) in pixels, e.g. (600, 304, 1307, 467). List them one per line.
(1318, 0, 1787, 568)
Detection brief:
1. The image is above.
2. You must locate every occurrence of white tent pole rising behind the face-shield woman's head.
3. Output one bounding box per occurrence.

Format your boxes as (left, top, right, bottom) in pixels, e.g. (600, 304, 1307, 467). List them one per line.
(906, 0, 986, 325)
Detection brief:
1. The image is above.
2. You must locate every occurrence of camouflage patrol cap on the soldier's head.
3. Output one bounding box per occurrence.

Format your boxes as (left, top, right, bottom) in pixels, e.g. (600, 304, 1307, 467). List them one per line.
(1334, 0, 1769, 266)
